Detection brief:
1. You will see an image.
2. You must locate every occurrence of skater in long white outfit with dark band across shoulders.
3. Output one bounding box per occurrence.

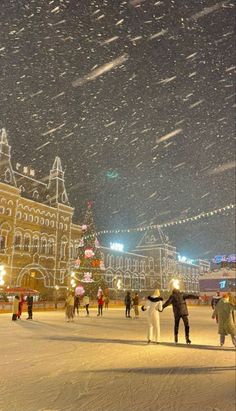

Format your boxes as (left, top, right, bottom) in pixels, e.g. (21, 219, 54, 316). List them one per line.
(142, 290, 163, 344)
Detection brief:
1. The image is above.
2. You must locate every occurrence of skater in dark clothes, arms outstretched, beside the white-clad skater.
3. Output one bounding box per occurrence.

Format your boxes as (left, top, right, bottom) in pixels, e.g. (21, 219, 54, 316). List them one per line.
(149, 288, 199, 344)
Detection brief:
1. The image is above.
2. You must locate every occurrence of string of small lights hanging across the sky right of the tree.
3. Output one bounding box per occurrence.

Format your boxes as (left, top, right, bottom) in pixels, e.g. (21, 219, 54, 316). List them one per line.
(86, 204, 235, 238)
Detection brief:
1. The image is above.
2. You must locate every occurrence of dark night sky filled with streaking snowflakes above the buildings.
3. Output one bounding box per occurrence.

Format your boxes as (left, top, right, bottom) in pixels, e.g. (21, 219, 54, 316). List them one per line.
(0, 0, 235, 258)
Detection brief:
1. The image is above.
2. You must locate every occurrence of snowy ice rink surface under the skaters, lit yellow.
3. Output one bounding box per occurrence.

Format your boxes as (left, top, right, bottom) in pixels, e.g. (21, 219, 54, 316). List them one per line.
(0, 307, 235, 411)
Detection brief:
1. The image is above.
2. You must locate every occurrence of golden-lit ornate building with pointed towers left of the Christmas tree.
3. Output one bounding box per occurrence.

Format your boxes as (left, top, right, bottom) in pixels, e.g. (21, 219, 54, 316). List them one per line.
(0, 129, 81, 290)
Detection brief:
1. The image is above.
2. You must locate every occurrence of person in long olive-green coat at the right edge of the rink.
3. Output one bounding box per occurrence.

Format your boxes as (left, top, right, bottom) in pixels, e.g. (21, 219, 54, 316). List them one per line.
(212, 294, 236, 347)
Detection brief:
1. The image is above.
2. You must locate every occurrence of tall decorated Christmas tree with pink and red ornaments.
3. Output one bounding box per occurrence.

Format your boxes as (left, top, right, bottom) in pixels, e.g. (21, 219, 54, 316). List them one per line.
(75, 201, 106, 295)
